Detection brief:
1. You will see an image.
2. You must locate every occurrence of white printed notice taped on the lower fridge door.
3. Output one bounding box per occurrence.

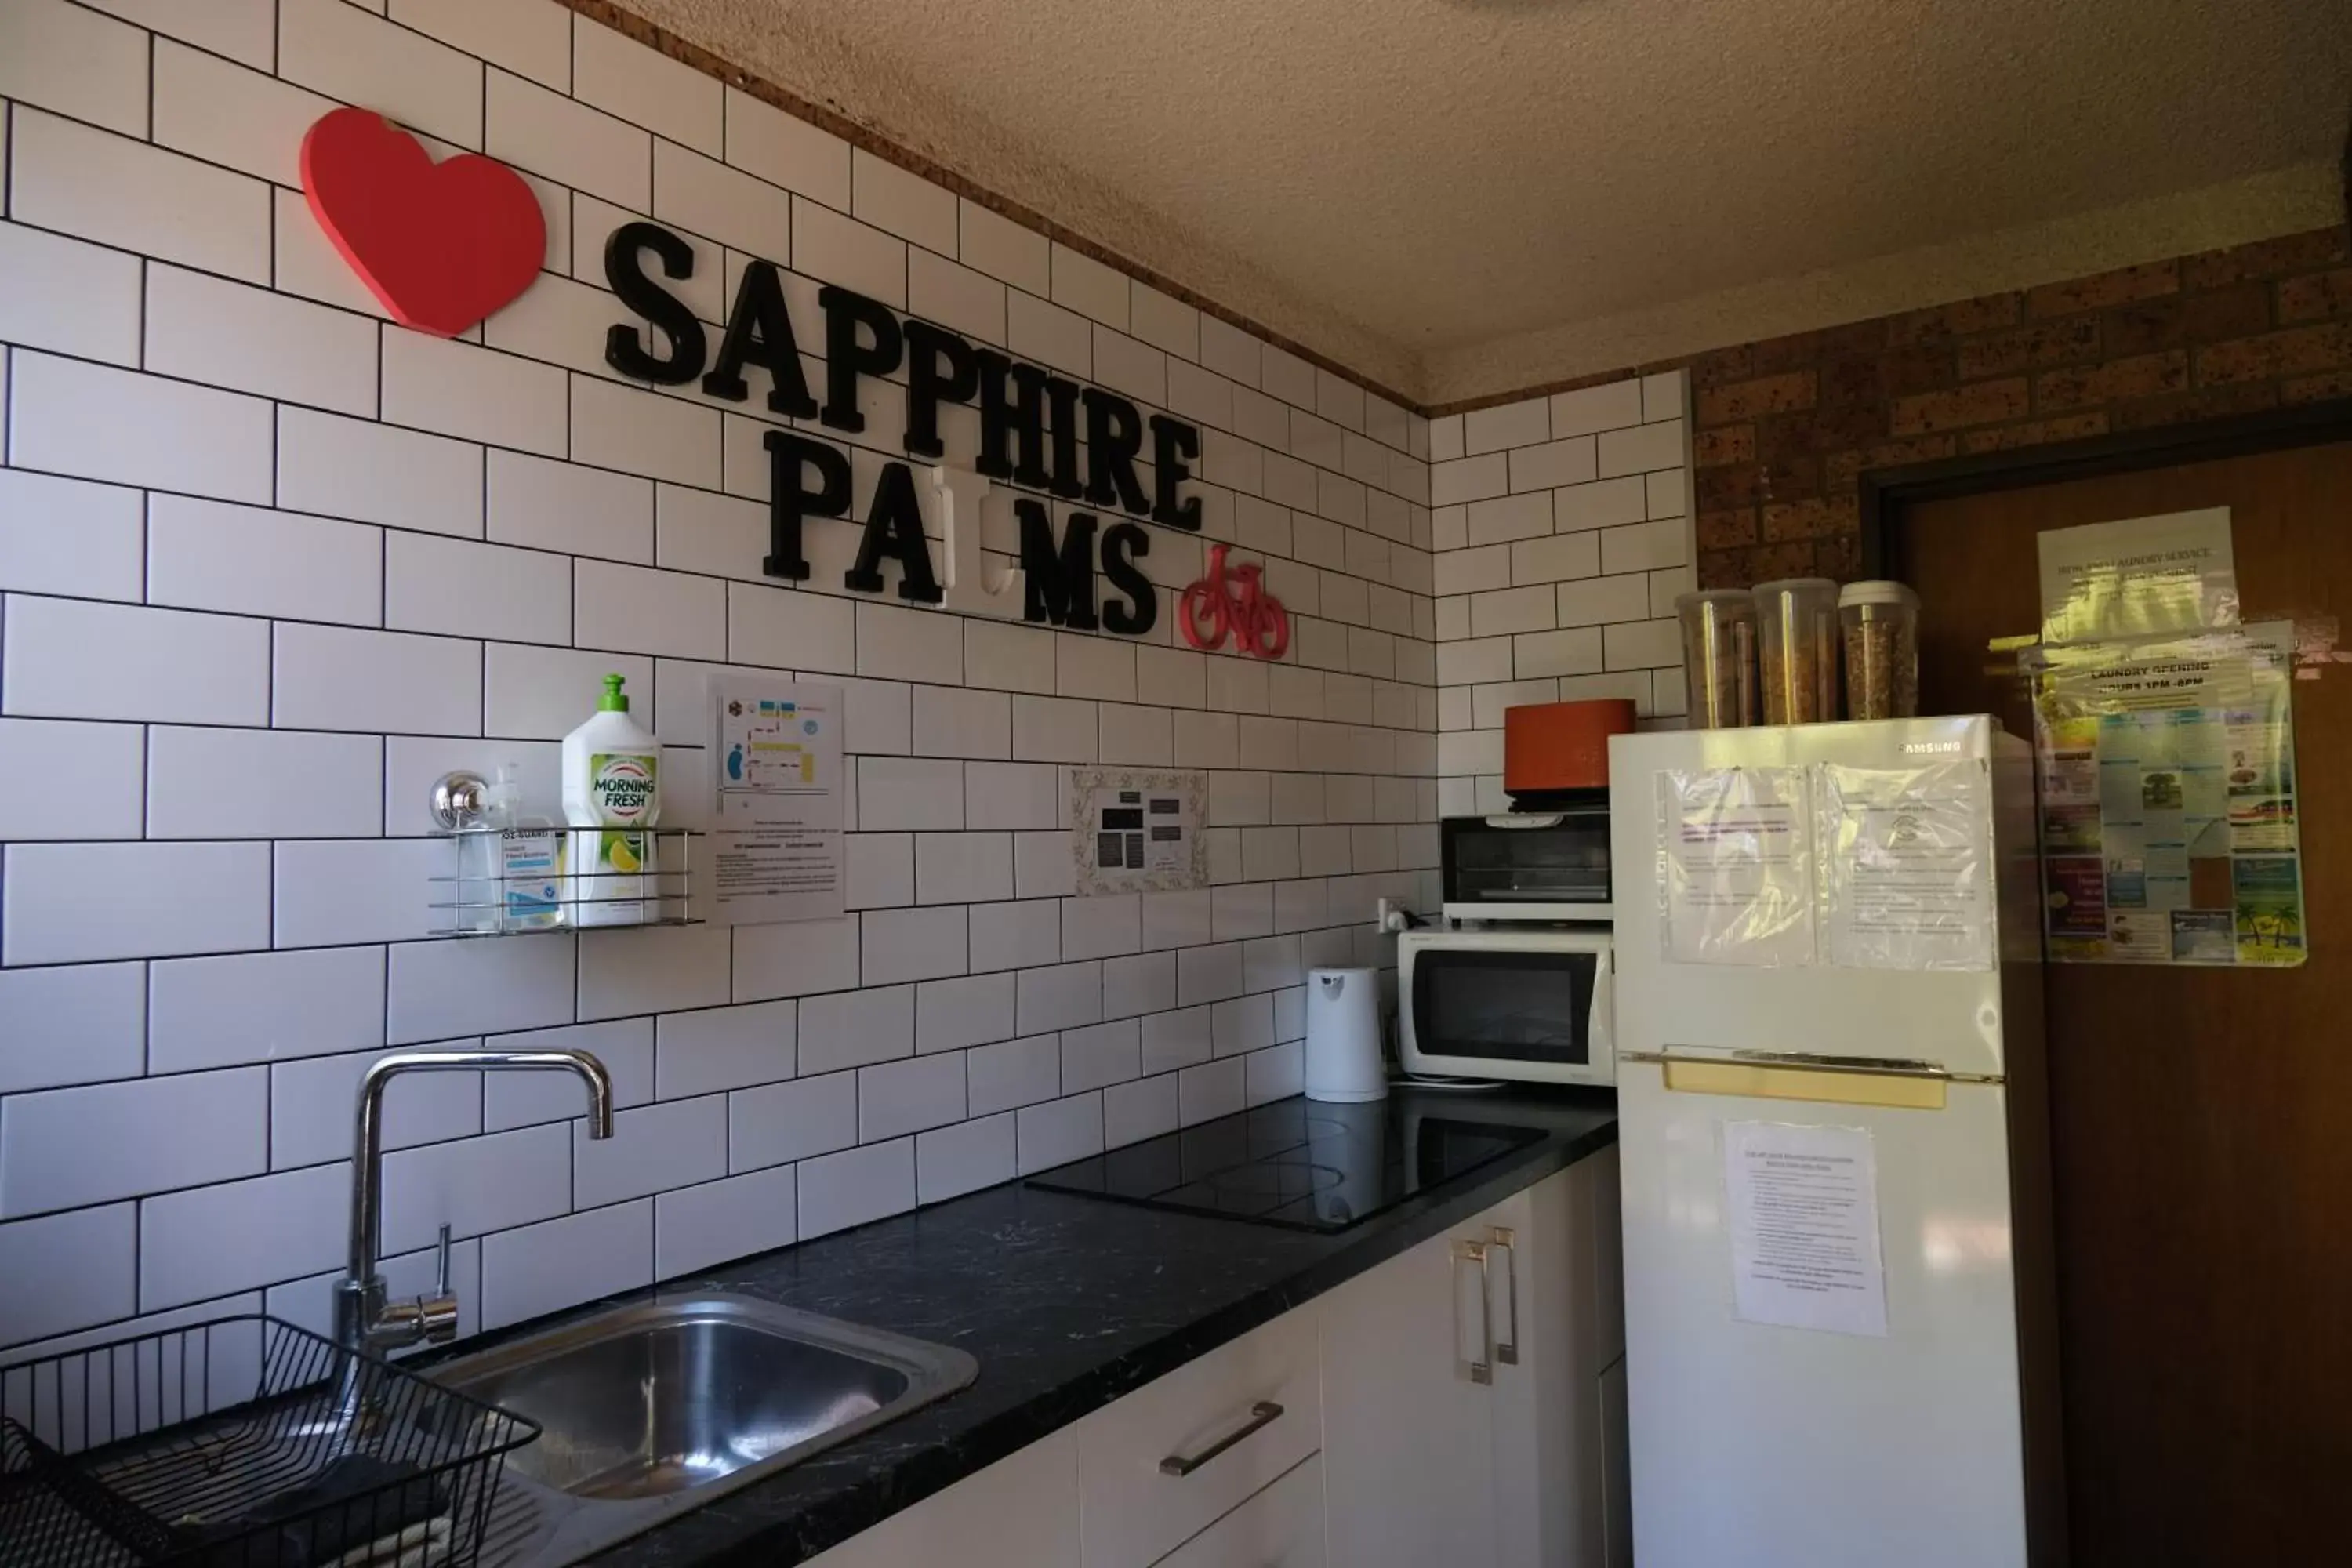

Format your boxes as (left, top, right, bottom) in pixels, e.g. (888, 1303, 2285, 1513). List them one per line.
(1724, 1121, 1886, 1338)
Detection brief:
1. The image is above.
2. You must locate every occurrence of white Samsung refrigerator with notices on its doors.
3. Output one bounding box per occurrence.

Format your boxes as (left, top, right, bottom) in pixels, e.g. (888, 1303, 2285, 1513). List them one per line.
(1609, 717, 2063, 1568)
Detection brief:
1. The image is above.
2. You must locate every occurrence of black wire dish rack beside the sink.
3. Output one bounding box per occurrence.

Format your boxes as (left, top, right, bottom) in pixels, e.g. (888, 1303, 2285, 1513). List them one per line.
(0, 1316, 539, 1568)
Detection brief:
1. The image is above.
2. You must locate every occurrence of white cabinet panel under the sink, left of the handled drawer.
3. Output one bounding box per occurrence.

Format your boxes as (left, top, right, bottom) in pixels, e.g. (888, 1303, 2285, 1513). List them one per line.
(809, 1427, 1077, 1568)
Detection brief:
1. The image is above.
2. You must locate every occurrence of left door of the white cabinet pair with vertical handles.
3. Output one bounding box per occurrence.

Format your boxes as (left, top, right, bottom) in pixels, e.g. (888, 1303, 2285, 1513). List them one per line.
(1322, 1225, 1496, 1568)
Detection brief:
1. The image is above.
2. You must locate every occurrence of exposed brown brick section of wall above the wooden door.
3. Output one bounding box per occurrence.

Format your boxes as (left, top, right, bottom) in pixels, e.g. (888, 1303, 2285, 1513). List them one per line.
(1684, 228, 2352, 588)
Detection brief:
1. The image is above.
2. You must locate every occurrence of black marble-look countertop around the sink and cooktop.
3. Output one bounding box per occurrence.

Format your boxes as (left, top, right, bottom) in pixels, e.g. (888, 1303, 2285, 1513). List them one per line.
(543, 1088, 1616, 1568)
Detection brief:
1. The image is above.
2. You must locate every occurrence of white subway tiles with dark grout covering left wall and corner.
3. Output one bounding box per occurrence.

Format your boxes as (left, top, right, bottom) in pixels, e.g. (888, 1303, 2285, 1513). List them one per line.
(0, 0, 1430, 1352)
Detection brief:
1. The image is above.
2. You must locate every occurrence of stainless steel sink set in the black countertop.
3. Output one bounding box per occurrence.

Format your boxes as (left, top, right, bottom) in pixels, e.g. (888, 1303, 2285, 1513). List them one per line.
(430, 1293, 978, 1563)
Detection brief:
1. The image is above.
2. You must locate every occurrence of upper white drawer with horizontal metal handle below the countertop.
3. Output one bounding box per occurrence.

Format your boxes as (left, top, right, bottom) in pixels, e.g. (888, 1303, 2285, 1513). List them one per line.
(1075, 1307, 1322, 1568)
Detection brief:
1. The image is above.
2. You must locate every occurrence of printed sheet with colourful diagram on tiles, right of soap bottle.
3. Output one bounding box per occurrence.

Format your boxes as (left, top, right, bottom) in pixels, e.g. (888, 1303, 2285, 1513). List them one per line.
(710, 675, 847, 926)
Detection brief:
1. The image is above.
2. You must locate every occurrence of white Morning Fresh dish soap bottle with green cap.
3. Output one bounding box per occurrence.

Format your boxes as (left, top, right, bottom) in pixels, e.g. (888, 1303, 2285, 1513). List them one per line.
(564, 675, 661, 926)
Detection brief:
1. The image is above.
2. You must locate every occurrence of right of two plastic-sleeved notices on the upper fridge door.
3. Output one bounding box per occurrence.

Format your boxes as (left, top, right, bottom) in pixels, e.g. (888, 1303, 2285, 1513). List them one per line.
(1813, 757, 1997, 968)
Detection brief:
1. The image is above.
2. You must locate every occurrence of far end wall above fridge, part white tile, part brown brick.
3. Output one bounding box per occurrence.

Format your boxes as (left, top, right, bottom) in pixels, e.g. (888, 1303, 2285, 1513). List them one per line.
(1430, 228, 2352, 785)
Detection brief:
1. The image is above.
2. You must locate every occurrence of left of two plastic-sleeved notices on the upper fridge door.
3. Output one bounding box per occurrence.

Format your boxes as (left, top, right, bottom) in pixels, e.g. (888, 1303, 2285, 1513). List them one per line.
(1658, 769, 1813, 966)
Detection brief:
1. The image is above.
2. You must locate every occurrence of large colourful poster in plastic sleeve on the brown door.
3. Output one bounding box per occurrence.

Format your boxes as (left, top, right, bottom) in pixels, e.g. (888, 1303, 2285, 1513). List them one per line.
(2027, 621, 2305, 964)
